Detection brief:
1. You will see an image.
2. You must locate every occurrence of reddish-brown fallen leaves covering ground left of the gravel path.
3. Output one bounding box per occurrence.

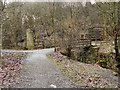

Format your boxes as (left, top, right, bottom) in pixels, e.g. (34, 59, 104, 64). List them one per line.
(0, 52, 27, 88)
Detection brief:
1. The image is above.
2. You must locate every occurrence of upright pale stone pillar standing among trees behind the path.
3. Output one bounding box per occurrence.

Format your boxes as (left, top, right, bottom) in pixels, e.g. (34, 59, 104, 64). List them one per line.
(26, 29, 34, 50)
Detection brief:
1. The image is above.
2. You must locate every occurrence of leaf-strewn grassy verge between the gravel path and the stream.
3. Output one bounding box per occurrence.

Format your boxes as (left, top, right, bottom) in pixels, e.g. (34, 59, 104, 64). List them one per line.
(50, 52, 118, 88)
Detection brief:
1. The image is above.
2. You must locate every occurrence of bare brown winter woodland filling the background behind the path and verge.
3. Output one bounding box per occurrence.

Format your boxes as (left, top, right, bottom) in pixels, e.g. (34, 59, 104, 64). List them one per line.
(0, 1, 120, 88)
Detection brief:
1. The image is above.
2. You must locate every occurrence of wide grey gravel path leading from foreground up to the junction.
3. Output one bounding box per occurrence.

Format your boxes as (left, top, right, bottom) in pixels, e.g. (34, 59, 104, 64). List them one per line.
(8, 48, 71, 88)
